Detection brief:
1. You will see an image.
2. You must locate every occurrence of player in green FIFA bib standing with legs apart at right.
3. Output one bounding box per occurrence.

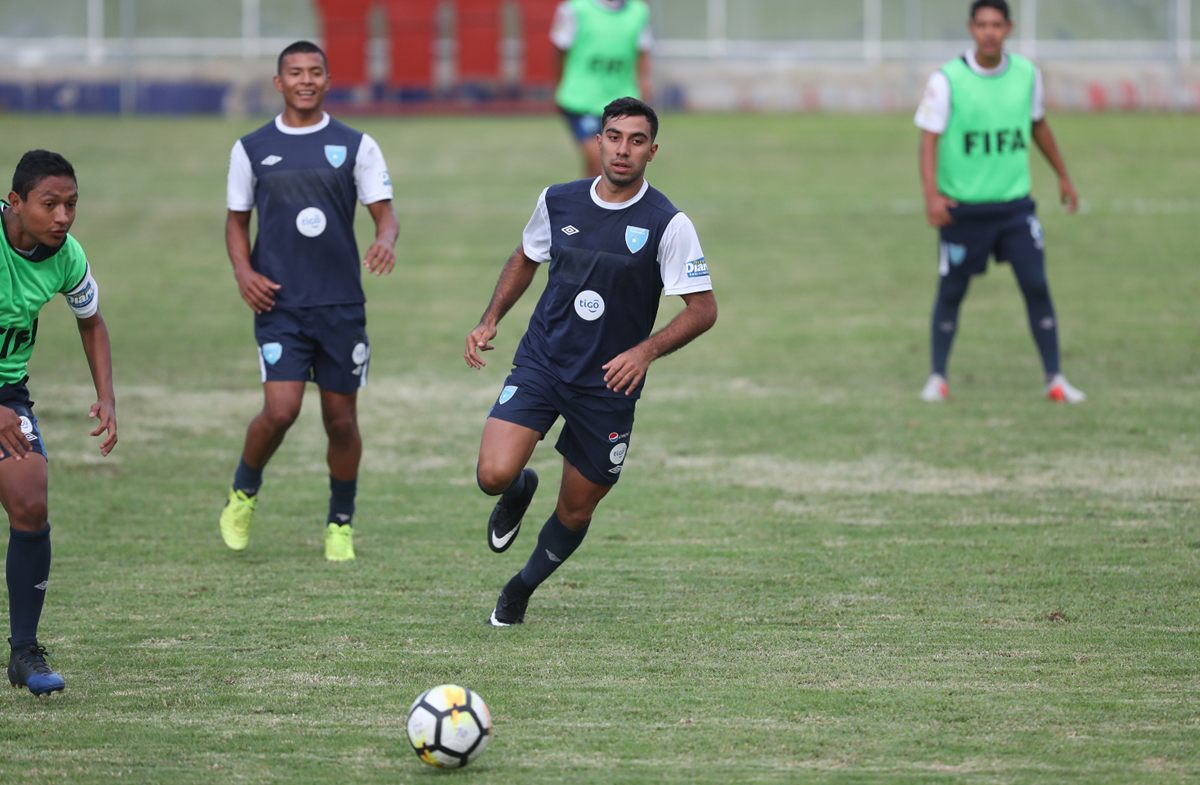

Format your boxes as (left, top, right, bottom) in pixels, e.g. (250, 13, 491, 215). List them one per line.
(916, 0, 1086, 403)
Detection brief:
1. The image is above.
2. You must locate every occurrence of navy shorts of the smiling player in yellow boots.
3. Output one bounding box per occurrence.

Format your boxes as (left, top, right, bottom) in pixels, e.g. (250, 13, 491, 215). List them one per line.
(254, 305, 371, 395)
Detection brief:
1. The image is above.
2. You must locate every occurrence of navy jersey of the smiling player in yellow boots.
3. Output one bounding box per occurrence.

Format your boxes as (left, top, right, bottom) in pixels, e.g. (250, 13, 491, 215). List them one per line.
(230, 119, 372, 308)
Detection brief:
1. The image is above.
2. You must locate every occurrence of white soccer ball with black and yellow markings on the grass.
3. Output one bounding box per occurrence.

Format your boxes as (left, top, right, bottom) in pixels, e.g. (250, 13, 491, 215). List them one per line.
(408, 684, 492, 768)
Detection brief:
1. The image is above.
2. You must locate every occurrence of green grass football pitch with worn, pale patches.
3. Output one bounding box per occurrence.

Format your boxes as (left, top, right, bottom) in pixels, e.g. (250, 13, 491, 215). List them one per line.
(0, 109, 1200, 785)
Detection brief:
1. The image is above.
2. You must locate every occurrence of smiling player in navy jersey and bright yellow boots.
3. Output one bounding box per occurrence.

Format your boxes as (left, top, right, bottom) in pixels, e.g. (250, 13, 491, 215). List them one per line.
(221, 41, 400, 562)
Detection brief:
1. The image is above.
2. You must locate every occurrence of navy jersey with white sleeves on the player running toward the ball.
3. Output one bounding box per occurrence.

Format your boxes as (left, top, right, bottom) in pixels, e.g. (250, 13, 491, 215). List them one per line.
(512, 180, 712, 399)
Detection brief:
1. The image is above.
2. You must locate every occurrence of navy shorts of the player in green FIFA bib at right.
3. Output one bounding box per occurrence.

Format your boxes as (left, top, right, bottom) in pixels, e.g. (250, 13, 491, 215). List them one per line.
(937, 198, 1045, 278)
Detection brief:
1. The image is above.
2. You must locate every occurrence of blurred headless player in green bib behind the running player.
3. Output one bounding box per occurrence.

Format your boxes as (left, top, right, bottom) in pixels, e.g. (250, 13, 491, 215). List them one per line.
(550, 0, 654, 178)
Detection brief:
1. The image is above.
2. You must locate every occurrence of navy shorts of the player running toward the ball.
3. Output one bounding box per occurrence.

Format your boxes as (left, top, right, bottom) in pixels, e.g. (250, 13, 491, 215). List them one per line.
(488, 367, 637, 485)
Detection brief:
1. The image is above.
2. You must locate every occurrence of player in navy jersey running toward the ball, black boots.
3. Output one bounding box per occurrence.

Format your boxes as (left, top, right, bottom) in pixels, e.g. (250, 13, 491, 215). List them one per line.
(463, 98, 716, 627)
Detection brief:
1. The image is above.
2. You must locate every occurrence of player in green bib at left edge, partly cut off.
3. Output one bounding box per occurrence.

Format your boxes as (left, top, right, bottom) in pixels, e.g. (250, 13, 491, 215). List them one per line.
(0, 150, 116, 695)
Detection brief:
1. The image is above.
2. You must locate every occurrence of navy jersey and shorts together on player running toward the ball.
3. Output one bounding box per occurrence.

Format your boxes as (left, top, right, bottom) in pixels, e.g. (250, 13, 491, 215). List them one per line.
(491, 180, 712, 485)
